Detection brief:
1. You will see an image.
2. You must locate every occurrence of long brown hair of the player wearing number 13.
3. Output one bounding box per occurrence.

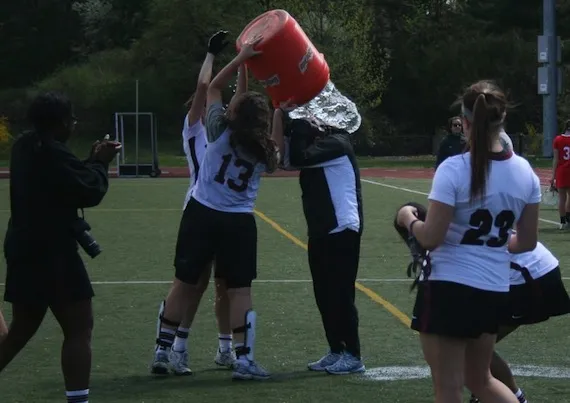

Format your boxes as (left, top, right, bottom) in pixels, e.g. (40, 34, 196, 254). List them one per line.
(228, 91, 278, 171)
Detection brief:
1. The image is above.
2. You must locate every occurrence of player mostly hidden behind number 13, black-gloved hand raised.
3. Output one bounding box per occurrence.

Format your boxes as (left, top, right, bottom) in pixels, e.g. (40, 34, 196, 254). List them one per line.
(151, 31, 235, 375)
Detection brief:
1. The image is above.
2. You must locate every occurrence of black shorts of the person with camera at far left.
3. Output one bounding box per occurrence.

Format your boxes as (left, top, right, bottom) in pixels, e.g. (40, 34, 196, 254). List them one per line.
(4, 250, 95, 306)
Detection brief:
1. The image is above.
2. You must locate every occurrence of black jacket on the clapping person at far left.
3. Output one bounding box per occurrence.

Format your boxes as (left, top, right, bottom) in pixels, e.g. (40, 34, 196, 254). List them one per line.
(4, 133, 109, 263)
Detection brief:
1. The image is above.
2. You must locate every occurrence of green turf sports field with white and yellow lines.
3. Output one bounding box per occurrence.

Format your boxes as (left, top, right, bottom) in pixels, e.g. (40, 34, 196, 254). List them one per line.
(0, 171, 570, 403)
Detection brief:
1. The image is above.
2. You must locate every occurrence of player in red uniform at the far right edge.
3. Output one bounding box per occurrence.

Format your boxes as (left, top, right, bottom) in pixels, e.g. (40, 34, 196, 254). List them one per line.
(550, 120, 570, 229)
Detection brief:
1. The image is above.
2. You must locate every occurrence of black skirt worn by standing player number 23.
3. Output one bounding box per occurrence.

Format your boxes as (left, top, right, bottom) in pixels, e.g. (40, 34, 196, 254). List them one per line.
(411, 281, 509, 339)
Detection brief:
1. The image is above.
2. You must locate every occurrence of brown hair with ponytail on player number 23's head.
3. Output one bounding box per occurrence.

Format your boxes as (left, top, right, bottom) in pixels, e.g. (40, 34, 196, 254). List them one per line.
(460, 80, 508, 200)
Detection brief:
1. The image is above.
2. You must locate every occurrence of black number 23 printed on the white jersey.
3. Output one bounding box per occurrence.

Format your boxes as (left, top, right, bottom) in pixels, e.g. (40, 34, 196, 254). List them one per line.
(461, 209, 515, 248)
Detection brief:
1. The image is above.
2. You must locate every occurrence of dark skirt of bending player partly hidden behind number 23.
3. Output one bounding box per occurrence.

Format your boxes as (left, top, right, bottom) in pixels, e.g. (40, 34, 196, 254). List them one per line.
(505, 267, 570, 326)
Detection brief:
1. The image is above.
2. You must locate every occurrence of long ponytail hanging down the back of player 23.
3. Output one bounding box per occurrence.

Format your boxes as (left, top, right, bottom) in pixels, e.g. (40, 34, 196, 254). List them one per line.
(465, 94, 492, 200)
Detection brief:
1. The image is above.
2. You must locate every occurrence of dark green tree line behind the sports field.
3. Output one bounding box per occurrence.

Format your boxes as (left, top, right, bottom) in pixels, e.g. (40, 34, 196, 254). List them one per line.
(0, 0, 570, 155)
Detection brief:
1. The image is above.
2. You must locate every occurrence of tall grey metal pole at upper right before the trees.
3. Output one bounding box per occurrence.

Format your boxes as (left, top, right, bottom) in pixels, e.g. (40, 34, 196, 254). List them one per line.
(542, 0, 558, 157)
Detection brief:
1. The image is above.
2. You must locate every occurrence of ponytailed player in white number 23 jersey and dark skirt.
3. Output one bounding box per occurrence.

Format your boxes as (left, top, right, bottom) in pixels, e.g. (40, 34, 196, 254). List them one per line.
(397, 81, 540, 403)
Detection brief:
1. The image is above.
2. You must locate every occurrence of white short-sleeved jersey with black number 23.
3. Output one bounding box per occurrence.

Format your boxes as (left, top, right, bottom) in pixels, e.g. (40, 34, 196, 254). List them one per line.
(428, 151, 541, 292)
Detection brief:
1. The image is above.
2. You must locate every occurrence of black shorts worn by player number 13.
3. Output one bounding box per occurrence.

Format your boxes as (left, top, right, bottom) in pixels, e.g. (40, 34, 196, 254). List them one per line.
(174, 198, 257, 288)
